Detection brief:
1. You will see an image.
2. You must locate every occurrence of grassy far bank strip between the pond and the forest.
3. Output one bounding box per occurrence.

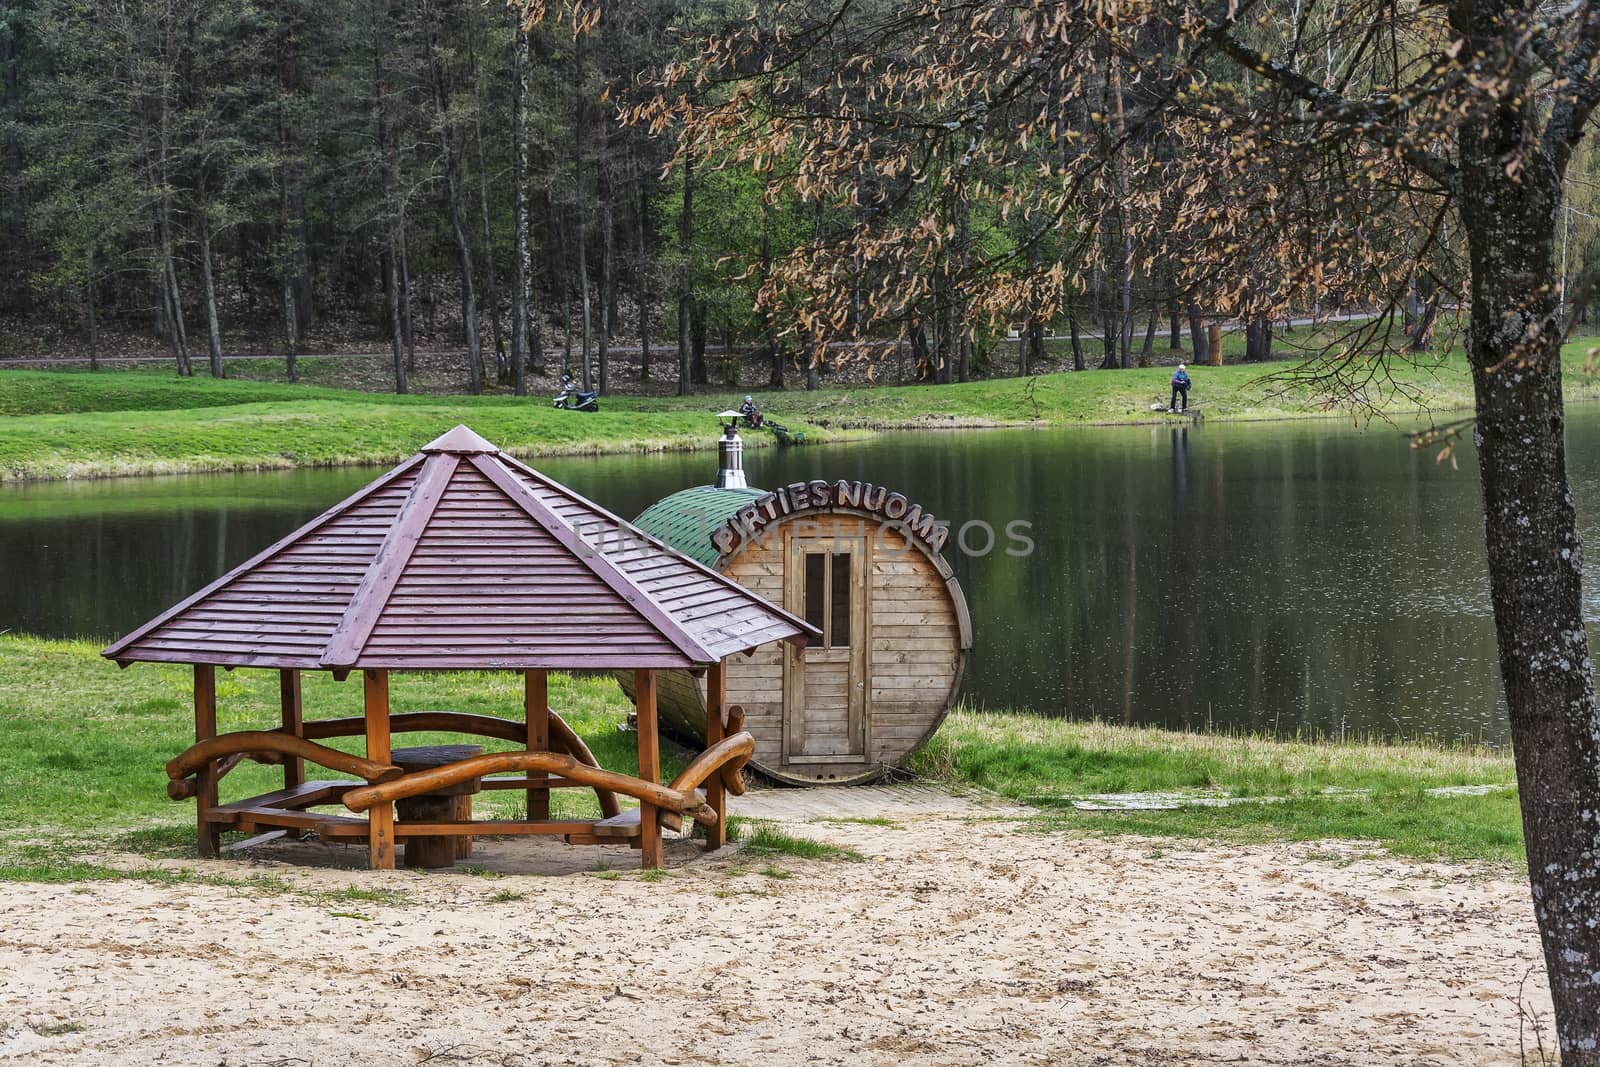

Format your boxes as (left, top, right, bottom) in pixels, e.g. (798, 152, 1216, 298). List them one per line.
(9, 341, 1600, 480)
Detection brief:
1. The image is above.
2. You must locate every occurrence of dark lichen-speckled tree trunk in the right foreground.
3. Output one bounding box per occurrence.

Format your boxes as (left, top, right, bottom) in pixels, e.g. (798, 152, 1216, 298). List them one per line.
(1461, 125, 1600, 1067)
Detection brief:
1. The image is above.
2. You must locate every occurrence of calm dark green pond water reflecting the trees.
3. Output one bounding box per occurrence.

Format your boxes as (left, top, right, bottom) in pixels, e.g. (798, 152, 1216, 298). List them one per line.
(9, 408, 1600, 741)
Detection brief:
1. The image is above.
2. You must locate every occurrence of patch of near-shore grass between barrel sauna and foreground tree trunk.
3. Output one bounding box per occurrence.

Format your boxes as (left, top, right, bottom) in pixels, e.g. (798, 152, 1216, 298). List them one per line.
(914, 710, 1523, 864)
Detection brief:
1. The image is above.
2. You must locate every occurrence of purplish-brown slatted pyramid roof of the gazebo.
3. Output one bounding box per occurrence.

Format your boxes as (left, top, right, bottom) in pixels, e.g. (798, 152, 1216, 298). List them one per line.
(104, 426, 814, 672)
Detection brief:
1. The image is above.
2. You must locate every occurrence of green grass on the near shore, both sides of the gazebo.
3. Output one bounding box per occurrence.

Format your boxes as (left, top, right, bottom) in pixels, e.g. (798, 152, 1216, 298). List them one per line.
(0, 635, 1522, 880)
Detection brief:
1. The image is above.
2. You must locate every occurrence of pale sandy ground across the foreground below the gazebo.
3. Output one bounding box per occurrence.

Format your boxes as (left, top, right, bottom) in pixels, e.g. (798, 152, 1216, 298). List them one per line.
(0, 790, 1549, 1067)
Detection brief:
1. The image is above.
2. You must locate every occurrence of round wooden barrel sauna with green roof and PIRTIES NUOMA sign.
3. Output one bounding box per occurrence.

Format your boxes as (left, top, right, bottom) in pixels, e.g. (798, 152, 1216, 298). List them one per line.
(619, 429, 973, 785)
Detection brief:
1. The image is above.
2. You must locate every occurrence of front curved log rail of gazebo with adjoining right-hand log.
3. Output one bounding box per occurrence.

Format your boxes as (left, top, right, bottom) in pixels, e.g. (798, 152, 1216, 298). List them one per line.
(342, 733, 755, 825)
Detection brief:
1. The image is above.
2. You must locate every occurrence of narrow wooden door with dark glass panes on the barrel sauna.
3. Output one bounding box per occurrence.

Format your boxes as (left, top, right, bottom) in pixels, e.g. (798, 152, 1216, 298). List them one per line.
(784, 518, 870, 763)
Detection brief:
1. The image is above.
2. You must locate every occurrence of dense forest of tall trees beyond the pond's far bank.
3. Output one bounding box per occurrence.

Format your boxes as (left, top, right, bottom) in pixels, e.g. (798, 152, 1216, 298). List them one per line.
(15, 0, 1594, 394)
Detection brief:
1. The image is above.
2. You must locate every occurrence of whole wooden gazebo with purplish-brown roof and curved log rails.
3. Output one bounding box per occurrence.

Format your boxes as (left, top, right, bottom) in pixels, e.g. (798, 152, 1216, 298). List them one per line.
(102, 426, 816, 869)
